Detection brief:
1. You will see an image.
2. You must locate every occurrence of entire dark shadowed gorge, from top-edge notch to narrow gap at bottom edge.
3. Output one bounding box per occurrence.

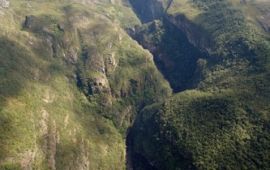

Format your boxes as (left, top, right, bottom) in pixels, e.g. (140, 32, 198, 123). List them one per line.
(126, 0, 207, 170)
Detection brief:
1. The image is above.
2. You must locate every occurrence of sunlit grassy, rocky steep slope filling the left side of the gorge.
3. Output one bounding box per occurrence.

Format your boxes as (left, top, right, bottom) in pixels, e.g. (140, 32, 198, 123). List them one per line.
(0, 0, 171, 170)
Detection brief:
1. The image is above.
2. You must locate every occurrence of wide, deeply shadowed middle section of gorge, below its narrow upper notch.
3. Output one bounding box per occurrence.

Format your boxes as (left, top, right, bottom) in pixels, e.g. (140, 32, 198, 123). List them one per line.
(126, 18, 206, 93)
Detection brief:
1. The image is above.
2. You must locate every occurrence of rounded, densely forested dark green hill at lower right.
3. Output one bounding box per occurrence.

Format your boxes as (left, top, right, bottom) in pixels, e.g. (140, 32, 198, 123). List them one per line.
(131, 91, 269, 169)
